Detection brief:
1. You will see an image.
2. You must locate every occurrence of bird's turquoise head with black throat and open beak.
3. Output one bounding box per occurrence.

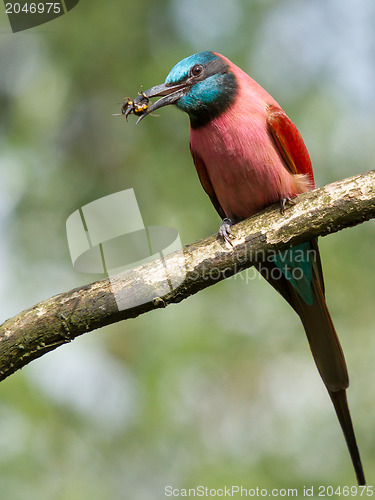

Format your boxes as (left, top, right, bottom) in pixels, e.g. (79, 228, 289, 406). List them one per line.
(138, 52, 237, 128)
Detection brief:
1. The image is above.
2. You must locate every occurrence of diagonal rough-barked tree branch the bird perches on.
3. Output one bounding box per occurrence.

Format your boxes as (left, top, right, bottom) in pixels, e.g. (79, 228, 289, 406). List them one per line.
(0, 171, 375, 380)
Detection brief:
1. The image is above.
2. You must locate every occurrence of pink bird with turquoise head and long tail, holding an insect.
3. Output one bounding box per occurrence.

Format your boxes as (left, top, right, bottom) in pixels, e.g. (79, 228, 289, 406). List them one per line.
(128, 51, 365, 485)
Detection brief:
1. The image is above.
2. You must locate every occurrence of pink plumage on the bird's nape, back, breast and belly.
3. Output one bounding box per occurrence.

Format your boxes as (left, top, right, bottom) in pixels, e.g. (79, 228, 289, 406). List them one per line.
(190, 55, 313, 221)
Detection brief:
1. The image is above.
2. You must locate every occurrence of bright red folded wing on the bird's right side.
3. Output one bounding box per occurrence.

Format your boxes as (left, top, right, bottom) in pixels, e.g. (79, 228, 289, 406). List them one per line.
(267, 105, 314, 188)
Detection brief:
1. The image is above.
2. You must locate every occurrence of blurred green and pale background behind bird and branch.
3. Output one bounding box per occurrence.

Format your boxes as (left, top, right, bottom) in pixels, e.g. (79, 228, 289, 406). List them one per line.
(0, 0, 375, 500)
